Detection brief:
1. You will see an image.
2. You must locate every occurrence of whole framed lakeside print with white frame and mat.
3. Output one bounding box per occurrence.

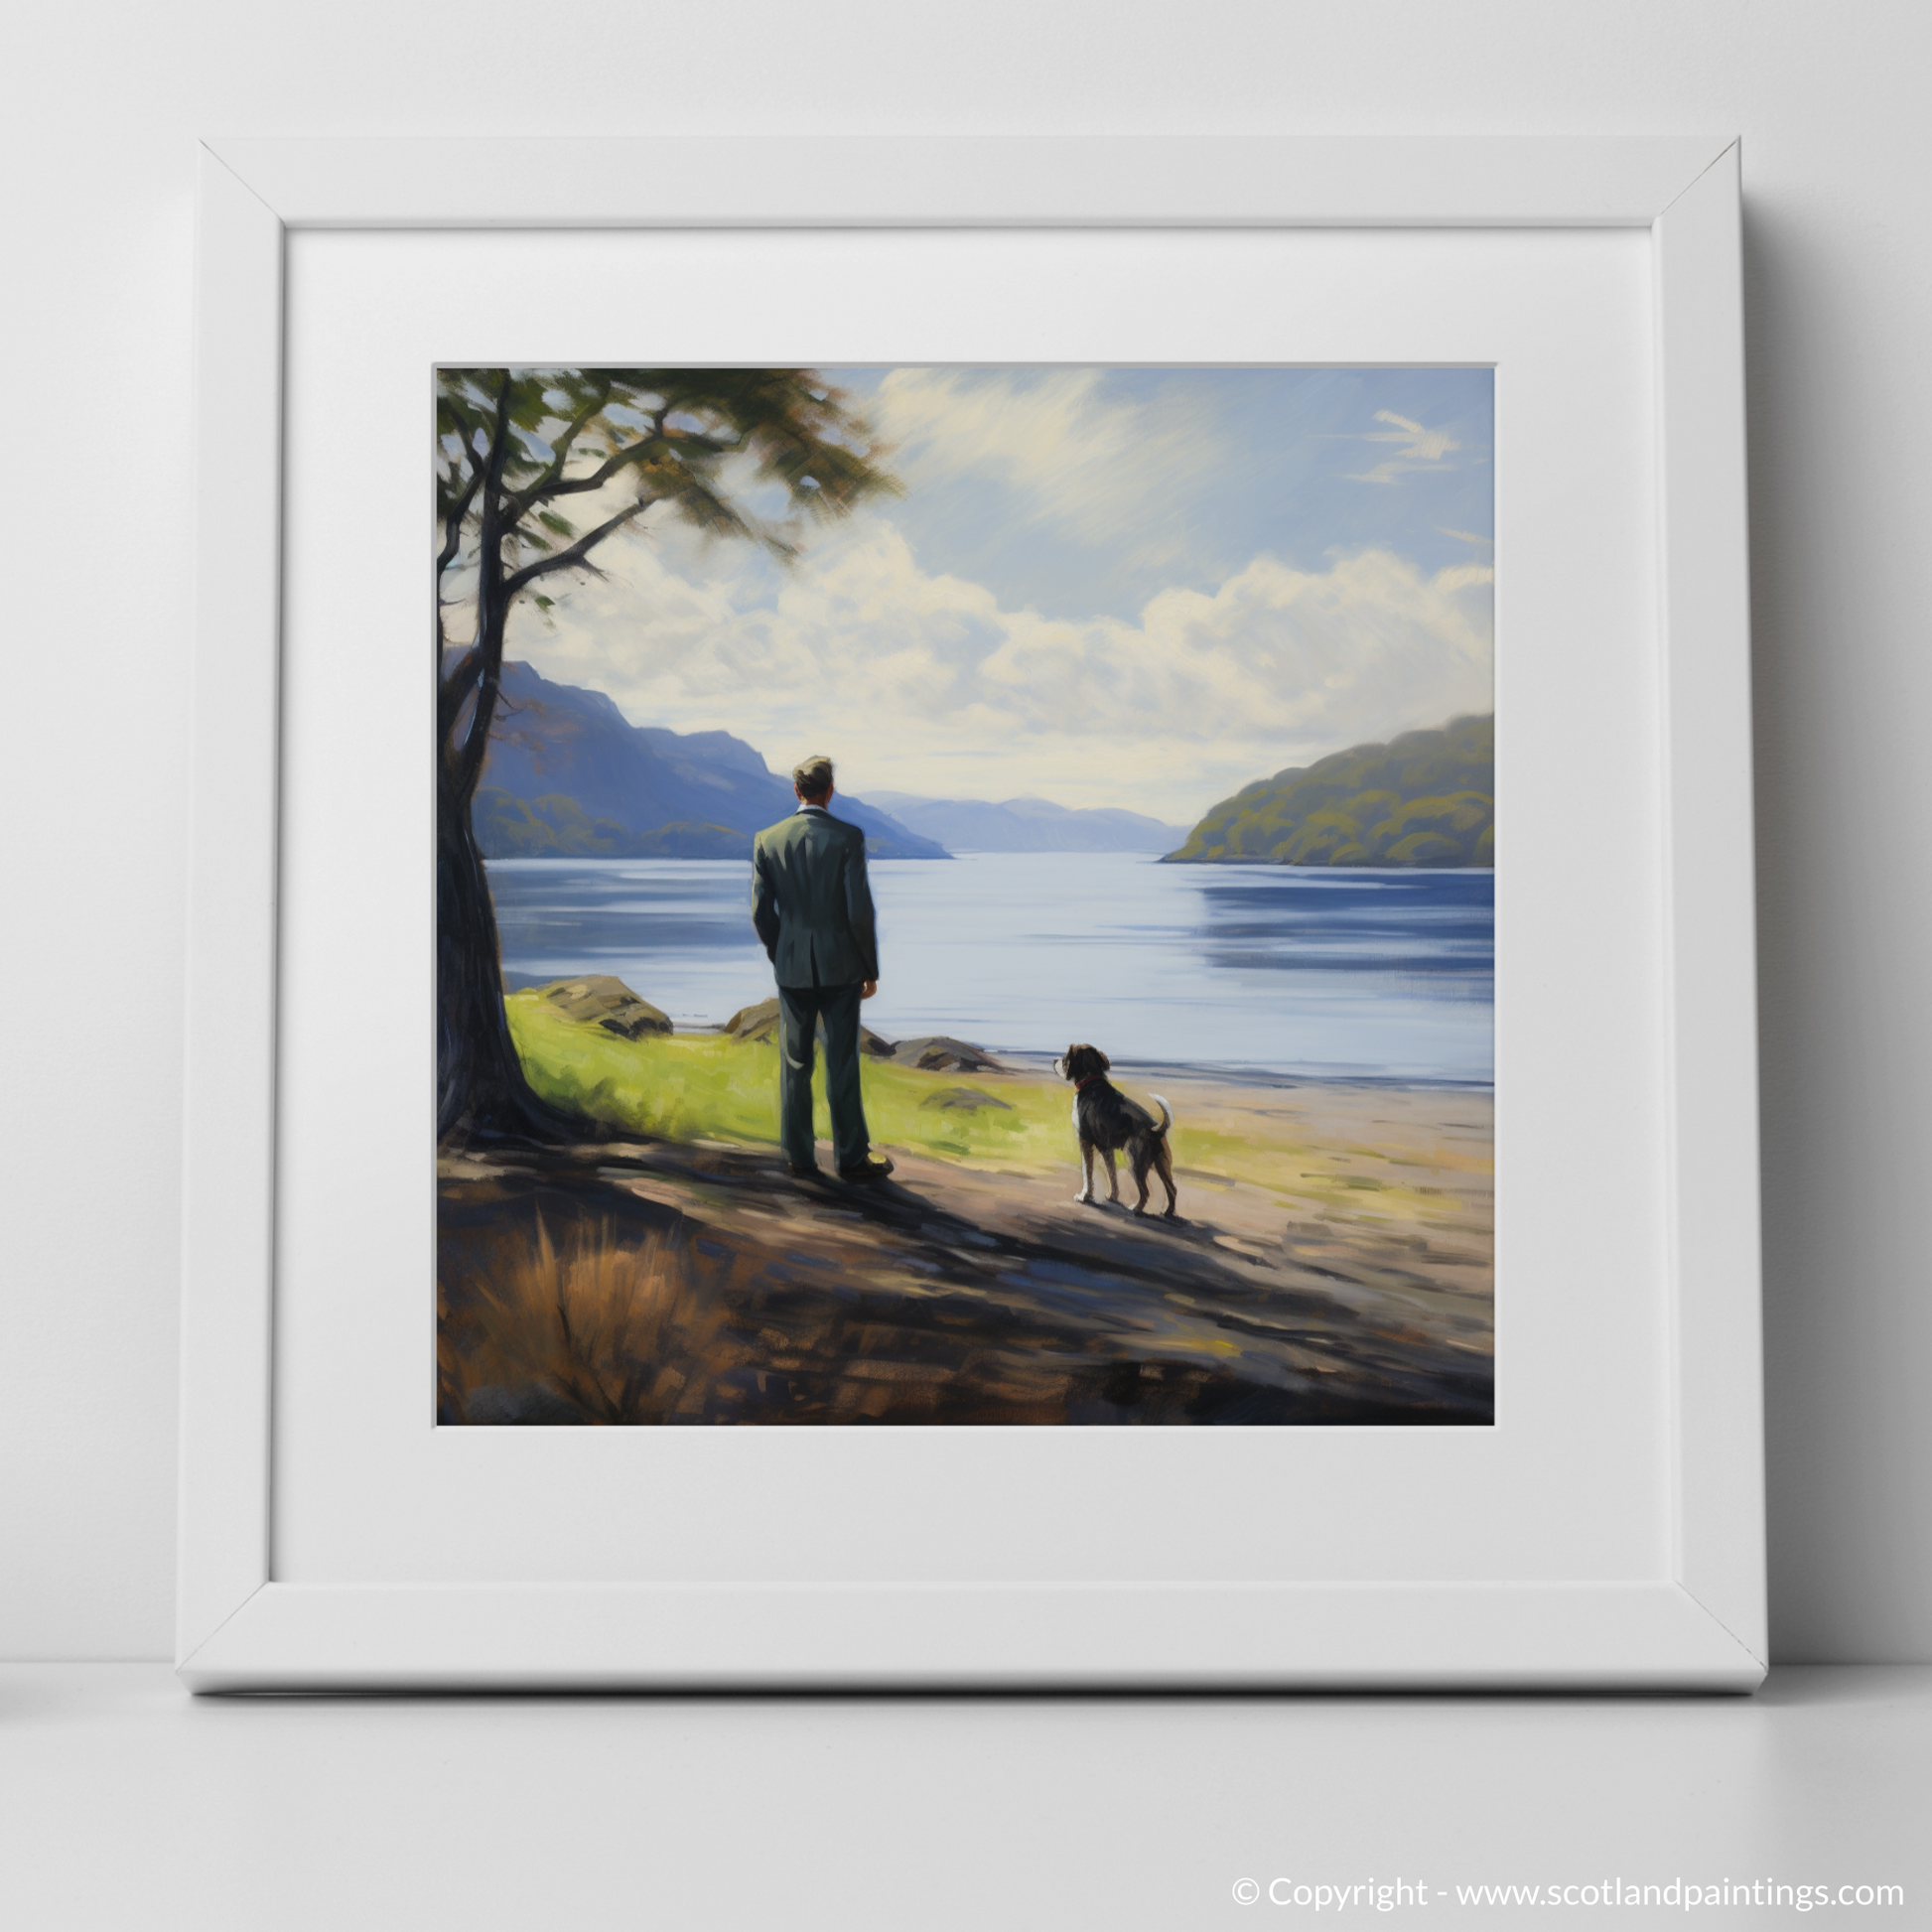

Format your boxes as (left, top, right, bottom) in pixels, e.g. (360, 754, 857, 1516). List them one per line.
(182, 141, 1764, 1689)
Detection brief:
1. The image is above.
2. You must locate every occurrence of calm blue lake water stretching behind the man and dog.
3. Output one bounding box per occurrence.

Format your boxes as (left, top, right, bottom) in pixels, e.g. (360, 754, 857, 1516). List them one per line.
(488, 852, 1495, 1082)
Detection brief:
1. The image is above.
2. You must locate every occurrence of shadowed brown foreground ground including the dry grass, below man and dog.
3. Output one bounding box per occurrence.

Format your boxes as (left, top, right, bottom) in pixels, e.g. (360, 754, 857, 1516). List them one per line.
(439, 1142, 1493, 1426)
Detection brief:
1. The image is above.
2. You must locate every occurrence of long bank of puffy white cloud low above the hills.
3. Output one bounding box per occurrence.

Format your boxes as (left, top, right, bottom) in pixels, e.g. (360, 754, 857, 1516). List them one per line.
(510, 516, 1491, 819)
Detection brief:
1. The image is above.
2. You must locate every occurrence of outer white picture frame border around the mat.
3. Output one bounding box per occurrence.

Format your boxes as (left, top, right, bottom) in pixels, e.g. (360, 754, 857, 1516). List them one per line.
(176, 137, 1768, 1691)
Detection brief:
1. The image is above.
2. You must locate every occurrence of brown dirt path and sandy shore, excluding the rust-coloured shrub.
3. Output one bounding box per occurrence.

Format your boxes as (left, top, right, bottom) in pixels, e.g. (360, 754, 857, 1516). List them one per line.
(443, 1080, 1491, 1422)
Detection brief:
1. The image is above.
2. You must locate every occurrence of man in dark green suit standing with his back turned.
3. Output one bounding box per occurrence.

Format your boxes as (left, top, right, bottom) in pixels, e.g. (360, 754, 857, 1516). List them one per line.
(752, 758, 893, 1180)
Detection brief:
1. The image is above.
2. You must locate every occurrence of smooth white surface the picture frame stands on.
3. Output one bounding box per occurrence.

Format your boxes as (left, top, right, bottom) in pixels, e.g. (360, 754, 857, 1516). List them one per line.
(0, 1664, 1932, 1932)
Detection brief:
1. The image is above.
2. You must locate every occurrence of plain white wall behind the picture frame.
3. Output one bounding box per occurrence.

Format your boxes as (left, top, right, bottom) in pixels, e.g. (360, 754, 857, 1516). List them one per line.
(0, 0, 1932, 1662)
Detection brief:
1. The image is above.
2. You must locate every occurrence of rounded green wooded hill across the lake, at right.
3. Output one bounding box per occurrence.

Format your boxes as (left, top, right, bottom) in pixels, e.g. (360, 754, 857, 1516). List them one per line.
(1167, 717, 1495, 870)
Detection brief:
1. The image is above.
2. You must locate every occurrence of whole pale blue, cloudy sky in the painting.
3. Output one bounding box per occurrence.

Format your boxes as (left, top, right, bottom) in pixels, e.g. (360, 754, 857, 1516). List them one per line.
(508, 367, 1493, 823)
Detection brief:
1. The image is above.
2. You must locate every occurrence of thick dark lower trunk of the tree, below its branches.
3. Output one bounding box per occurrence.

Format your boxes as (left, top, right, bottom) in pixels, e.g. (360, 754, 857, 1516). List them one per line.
(437, 759, 590, 1146)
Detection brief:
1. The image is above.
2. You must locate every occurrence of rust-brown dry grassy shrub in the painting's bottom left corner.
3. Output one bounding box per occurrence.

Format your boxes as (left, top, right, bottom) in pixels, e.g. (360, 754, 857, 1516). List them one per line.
(437, 1215, 736, 1424)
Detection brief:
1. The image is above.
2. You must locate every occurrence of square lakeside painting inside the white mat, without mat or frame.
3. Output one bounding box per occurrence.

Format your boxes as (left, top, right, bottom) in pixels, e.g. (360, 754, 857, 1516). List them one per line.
(425, 365, 1495, 1428)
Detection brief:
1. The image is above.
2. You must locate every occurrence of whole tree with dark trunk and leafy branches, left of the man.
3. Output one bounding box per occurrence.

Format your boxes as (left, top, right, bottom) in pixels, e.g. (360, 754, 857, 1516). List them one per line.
(435, 369, 898, 1142)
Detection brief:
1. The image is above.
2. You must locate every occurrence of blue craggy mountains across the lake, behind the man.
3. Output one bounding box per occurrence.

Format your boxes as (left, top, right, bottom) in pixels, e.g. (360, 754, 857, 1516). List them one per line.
(476, 662, 950, 858)
